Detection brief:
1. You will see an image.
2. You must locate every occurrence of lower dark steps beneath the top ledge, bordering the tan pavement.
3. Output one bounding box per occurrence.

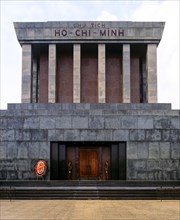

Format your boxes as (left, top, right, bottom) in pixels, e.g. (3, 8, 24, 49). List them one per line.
(0, 186, 180, 199)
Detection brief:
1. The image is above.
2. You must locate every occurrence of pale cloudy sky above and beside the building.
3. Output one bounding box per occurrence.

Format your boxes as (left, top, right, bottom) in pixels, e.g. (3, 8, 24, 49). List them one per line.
(0, 0, 180, 109)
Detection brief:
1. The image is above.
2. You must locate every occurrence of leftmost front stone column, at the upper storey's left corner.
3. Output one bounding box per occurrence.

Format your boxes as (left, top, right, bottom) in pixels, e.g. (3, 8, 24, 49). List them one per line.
(21, 44, 32, 103)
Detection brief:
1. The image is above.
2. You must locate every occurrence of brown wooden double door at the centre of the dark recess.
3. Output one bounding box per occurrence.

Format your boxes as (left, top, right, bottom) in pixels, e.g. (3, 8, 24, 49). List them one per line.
(80, 149, 98, 179)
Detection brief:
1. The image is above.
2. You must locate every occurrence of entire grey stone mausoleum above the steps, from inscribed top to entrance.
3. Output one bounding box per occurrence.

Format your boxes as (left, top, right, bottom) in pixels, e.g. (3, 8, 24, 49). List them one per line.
(0, 21, 180, 180)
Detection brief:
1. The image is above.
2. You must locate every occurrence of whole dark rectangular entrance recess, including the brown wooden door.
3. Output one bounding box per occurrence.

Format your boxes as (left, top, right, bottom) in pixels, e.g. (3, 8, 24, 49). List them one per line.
(50, 142, 126, 180)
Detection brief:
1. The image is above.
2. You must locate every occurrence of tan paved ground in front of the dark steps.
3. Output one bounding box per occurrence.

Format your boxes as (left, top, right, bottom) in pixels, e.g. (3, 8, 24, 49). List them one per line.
(1, 200, 179, 220)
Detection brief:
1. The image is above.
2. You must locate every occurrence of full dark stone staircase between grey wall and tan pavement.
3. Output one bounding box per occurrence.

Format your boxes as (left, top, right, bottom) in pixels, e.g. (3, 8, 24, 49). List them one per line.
(0, 180, 180, 200)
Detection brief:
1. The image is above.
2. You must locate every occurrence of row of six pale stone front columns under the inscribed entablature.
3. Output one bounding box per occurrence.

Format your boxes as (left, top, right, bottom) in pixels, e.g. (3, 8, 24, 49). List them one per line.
(22, 43, 157, 103)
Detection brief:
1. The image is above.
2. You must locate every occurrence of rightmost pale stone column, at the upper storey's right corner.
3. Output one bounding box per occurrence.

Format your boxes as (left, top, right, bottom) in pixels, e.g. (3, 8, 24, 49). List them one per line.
(147, 44, 157, 103)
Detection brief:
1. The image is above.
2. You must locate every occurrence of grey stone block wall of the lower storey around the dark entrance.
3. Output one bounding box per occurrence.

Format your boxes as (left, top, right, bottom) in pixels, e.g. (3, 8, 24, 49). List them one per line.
(0, 103, 180, 180)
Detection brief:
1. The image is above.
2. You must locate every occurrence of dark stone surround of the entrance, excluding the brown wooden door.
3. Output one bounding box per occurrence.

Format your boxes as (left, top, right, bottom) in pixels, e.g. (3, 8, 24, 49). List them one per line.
(50, 141, 127, 180)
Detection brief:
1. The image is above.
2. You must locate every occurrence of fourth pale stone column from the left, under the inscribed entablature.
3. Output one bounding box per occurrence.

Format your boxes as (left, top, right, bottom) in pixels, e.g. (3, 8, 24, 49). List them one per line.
(98, 44, 106, 103)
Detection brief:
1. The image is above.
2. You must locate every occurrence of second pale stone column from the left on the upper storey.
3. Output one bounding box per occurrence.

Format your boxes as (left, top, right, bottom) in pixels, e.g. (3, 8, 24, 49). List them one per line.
(48, 44, 56, 103)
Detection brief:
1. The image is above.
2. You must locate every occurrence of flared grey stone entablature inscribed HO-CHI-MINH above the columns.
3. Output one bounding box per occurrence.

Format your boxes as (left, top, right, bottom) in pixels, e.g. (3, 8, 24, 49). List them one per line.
(14, 21, 165, 44)
